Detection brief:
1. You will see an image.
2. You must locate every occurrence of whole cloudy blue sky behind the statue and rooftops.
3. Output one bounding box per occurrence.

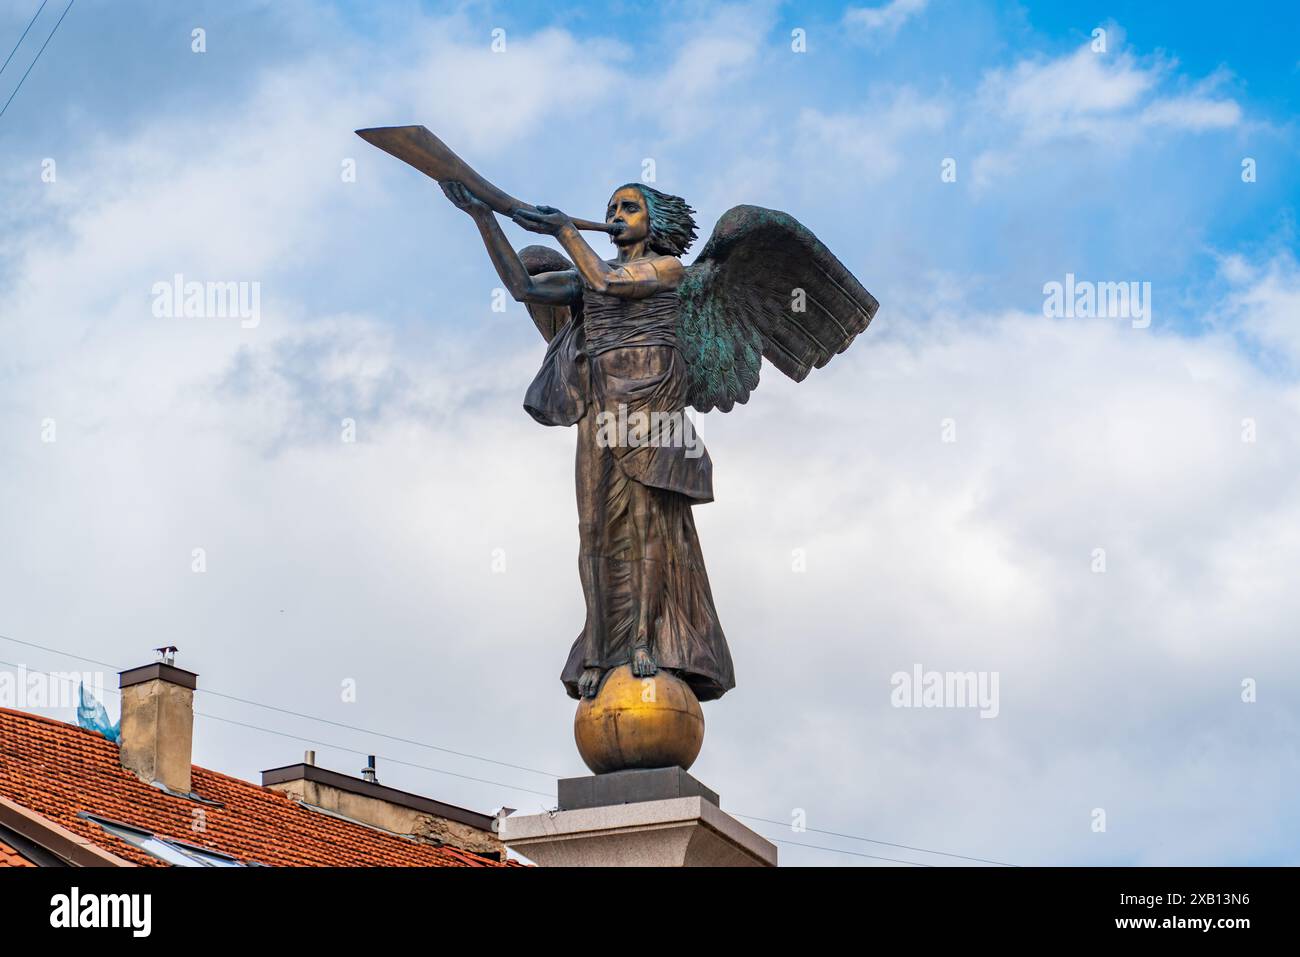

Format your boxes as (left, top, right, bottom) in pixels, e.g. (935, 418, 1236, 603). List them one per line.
(0, 0, 1300, 865)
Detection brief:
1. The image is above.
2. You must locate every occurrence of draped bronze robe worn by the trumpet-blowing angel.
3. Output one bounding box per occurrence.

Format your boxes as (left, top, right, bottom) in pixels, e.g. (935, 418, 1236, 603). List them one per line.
(524, 289, 736, 701)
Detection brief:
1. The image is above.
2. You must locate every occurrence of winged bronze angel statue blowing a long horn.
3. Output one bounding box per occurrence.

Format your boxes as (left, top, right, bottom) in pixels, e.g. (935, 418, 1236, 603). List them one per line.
(359, 127, 878, 701)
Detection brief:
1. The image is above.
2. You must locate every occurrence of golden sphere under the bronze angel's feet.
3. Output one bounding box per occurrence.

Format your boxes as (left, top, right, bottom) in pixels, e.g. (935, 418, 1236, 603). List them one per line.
(573, 664, 705, 774)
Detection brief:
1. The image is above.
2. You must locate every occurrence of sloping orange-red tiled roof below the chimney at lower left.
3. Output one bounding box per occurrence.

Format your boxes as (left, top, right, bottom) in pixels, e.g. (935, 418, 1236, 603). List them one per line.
(0, 707, 502, 867)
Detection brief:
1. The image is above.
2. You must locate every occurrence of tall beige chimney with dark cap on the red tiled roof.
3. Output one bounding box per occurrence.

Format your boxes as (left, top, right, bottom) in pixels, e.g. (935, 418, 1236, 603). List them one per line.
(118, 648, 199, 794)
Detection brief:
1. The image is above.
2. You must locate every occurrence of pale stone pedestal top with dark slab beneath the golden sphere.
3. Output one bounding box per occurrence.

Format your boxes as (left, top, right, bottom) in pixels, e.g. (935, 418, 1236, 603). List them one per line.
(501, 767, 776, 867)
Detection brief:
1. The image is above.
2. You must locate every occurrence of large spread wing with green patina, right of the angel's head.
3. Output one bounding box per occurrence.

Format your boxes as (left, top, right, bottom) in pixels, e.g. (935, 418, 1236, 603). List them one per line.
(677, 205, 880, 412)
